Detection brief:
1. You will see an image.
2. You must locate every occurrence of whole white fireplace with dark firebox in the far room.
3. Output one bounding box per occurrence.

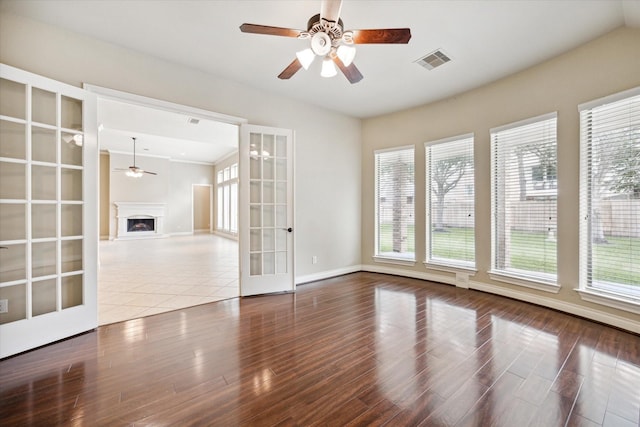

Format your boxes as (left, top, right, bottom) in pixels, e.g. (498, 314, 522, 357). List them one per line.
(114, 202, 166, 240)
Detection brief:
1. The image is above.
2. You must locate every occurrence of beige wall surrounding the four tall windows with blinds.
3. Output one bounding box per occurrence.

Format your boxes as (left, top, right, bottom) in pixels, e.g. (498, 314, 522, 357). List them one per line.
(362, 28, 640, 328)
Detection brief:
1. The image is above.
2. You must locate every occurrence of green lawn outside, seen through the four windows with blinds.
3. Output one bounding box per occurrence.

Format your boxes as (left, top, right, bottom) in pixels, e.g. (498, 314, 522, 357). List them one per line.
(380, 226, 640, 286)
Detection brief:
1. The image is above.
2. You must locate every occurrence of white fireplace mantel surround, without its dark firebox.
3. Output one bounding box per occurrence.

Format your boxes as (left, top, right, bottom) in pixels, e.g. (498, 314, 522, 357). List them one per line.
(113, 202, 167, 240)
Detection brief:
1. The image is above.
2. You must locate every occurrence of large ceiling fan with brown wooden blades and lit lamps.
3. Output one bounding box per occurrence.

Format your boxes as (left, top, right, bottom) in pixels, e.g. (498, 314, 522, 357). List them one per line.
(240, 0, 411, 83)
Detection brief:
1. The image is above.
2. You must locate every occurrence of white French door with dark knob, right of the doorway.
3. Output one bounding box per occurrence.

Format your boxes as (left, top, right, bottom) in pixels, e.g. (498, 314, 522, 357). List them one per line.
(239, 125, 295, 296)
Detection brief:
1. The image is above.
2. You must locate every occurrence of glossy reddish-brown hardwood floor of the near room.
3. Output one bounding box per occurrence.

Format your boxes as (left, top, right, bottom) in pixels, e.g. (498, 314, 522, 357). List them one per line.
(0, 273, 640, 427)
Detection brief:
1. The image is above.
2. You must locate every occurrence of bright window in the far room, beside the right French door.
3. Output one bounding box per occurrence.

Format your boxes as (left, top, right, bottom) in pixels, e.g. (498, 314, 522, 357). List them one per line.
(216, 163, 238, 234)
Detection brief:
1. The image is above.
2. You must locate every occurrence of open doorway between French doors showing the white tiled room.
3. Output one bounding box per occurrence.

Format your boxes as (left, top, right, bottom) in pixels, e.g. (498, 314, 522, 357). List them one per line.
(86, 86, 244, 325)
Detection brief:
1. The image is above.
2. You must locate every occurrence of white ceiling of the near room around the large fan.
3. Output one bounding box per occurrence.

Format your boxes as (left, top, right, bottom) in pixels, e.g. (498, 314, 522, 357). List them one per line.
(0, 0, 640, 117)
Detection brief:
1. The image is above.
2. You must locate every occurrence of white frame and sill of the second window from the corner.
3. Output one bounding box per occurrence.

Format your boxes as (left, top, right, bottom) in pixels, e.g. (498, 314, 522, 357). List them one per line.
(423, 132, 477, 274)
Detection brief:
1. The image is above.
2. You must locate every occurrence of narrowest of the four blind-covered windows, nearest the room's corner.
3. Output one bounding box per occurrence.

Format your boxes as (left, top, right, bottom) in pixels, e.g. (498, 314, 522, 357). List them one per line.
(375, 147, 415, 261)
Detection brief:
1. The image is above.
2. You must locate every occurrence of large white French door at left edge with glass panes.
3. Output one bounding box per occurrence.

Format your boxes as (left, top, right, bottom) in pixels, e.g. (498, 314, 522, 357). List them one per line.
(0, 64, 98, 357)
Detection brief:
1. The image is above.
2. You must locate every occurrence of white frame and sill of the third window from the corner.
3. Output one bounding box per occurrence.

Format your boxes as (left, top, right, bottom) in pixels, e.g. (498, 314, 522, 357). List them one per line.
(488, 111, 561, 293)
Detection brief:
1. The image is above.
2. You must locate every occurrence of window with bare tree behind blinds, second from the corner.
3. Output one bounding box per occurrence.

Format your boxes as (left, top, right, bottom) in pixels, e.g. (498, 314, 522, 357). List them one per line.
(425, 135, 475, 269)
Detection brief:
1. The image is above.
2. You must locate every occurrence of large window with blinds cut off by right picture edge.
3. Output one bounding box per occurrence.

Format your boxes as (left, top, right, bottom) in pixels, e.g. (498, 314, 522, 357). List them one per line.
(580, 88, 640, 312)
